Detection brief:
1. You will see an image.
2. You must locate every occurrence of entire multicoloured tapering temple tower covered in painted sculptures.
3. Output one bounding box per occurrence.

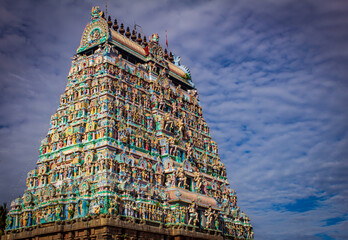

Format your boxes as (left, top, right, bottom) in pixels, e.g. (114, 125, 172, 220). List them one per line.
(2, 7, 254, 240)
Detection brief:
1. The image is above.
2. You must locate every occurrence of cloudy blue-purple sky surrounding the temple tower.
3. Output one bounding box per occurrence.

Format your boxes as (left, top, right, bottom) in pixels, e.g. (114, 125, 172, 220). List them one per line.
(0, 0, 348, 240)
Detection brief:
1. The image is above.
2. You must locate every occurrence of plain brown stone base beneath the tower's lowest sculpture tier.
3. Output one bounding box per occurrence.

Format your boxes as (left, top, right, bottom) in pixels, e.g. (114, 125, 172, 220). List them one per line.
(1, 215, 230, 240)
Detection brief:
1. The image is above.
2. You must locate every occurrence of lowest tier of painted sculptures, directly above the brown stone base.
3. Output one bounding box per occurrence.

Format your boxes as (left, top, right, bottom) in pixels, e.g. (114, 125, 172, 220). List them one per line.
(7, 189, 253, 238)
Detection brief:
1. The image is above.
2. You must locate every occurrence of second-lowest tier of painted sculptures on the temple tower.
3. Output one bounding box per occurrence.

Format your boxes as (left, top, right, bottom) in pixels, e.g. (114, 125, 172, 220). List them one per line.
(27, 150, 237, 204)
